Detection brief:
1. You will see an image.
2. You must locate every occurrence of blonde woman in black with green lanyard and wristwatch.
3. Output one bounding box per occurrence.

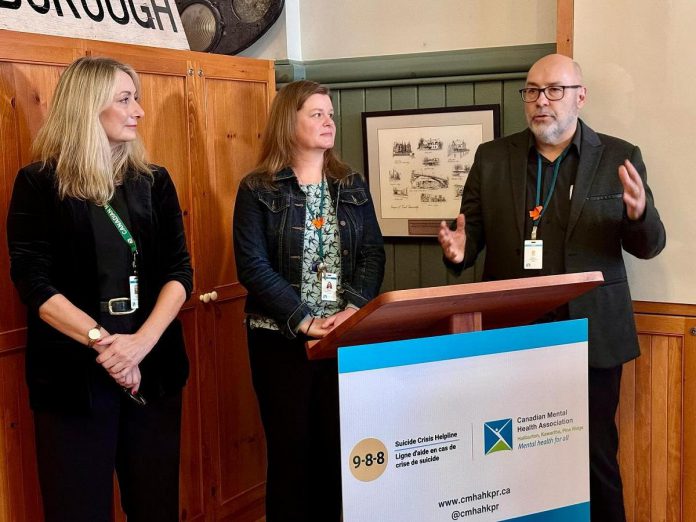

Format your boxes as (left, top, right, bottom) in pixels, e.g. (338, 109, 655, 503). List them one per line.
(7, 58, 192, 522)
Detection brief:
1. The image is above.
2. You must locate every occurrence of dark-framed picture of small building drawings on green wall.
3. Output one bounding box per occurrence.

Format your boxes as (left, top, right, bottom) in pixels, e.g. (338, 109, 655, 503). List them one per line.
(362, 105, 500, 236)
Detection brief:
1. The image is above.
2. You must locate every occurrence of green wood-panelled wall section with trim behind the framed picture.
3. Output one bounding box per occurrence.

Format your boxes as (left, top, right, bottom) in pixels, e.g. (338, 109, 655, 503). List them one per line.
(276, 44, 555, 291)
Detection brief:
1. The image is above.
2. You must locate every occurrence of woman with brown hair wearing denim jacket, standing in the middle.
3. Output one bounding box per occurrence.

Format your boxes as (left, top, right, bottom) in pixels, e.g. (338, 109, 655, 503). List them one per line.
(234, 81, 385, 522)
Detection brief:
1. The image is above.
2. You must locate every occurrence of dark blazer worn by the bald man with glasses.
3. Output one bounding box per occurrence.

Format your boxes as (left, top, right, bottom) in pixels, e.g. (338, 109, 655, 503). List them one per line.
(454, 121, 665, 368)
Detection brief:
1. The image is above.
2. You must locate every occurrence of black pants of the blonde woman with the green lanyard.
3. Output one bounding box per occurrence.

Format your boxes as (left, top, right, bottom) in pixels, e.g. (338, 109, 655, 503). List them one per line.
(34, 364, 181, 522)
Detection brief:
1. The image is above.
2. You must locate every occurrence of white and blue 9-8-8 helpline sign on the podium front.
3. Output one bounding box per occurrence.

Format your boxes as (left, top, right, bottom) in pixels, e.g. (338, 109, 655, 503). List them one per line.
(338, 320, 589, 522)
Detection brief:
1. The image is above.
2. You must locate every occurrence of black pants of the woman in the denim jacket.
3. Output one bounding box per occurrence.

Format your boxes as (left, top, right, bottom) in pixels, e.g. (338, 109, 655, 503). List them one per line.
(247, 328, 341, 522)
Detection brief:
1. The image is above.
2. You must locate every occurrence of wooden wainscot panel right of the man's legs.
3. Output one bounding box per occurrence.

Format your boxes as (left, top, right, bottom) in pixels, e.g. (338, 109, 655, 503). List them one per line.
(617, 313, 696, 522)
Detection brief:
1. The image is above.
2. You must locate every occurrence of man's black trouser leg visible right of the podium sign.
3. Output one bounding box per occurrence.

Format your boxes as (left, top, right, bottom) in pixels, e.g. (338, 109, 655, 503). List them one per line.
(588, 366, 626, 522)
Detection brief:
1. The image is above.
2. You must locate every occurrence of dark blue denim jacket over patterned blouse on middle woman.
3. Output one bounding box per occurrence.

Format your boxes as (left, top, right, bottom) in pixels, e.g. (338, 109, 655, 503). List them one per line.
(233, 168, 385, 338)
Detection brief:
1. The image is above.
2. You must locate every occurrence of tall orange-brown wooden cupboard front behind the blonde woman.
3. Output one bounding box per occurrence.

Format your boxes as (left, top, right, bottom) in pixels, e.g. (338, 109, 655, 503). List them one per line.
(0, 31, 275, 522)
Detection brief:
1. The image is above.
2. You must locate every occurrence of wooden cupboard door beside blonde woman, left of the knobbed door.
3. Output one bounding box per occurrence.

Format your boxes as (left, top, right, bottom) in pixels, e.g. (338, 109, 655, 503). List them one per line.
(86, 42, 207, 521)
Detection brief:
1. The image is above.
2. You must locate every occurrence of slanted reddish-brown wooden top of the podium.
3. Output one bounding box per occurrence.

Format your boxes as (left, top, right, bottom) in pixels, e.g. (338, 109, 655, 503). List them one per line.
(307, 272, 604, 359)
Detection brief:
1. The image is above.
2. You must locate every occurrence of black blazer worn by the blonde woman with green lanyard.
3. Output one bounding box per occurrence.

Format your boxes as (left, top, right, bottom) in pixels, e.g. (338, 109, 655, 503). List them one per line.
(7, 163, 193, 411)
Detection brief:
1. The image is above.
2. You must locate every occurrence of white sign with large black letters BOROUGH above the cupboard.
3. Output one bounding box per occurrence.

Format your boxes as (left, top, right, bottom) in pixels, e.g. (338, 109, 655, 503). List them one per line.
(0, 0, 189, 50)
